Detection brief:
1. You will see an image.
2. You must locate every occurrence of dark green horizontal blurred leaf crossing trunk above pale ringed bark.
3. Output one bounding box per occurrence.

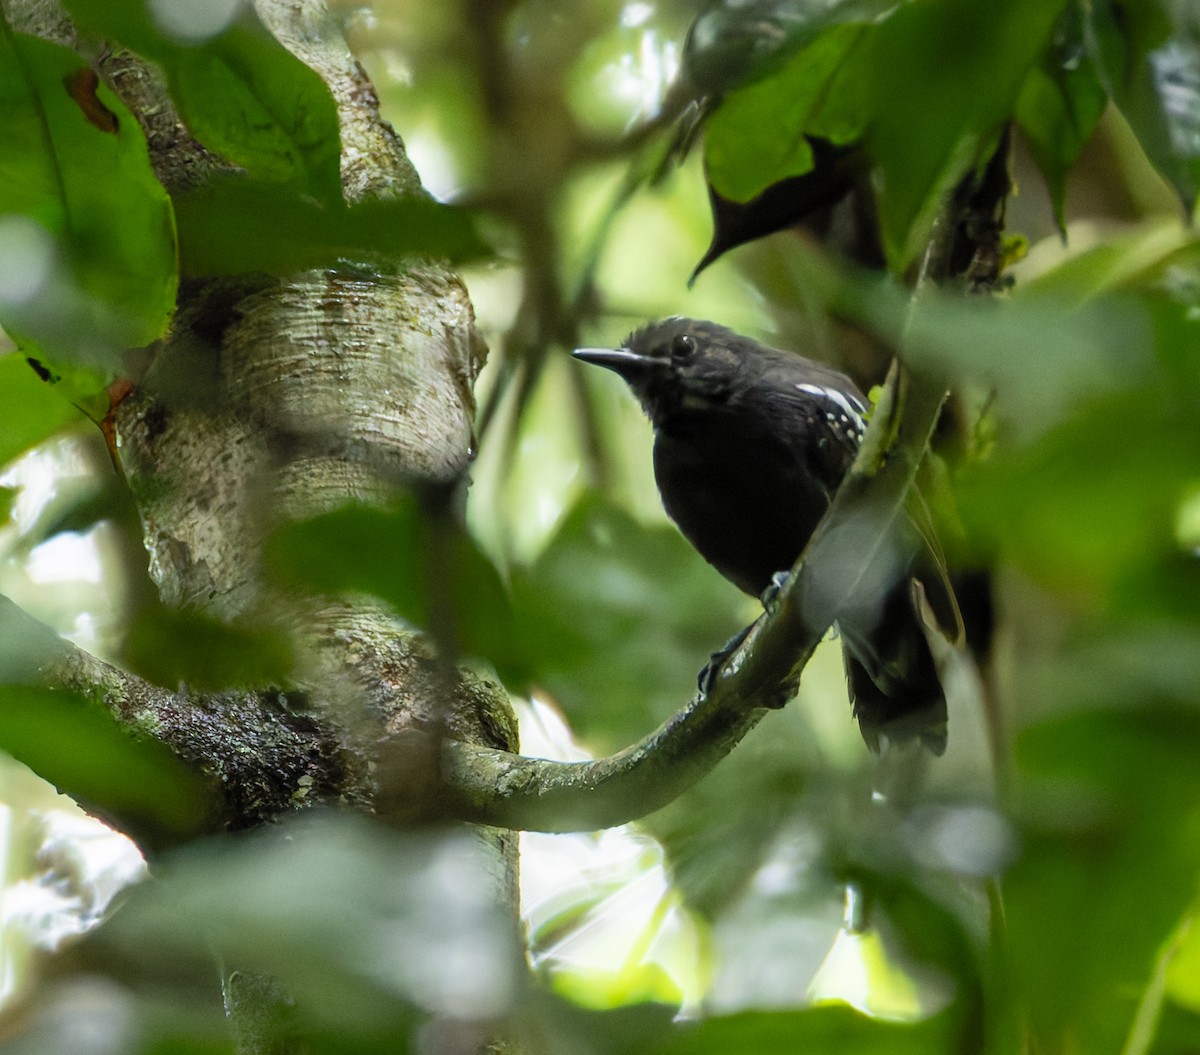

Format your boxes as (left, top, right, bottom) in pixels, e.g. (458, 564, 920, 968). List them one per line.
(175, 179, 490, 275)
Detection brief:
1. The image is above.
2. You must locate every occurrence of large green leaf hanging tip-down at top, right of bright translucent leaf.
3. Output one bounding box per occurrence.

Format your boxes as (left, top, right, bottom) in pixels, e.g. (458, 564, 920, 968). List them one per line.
(860, 0, 1066, 272)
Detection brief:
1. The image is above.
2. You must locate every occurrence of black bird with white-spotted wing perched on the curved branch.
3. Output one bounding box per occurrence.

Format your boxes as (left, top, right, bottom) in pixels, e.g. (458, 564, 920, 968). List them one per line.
(575, 317, 956, 754)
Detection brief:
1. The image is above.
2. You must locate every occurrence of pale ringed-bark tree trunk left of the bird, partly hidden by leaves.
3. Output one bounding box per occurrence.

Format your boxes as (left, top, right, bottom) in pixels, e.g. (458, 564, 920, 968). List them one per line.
(6, 0, 516, 1041)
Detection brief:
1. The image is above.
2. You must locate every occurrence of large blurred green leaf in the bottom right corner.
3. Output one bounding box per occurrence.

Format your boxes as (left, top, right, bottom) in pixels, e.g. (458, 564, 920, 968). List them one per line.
(1004, 699, 1200, 1051)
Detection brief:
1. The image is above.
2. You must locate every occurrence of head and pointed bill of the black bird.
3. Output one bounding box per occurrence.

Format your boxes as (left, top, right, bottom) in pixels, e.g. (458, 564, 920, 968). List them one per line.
(574, 316, 746, 424)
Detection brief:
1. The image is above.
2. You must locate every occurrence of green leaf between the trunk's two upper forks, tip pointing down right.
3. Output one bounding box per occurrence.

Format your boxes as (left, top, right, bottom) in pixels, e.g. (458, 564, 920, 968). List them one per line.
(65, 0, 341, 204)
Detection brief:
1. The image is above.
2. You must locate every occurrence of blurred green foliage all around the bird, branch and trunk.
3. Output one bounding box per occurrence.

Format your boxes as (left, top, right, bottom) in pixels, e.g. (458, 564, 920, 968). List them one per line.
(0, 0, 1200, 1055)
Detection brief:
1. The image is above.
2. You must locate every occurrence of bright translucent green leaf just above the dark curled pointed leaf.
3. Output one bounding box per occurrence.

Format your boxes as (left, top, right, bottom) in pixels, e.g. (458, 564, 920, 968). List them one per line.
(704, 25, 868, 202)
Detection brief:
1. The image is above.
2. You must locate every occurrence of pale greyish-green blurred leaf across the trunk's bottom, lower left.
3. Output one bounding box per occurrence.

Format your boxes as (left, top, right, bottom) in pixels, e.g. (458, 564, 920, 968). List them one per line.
(102, 813, 524, 1032)
